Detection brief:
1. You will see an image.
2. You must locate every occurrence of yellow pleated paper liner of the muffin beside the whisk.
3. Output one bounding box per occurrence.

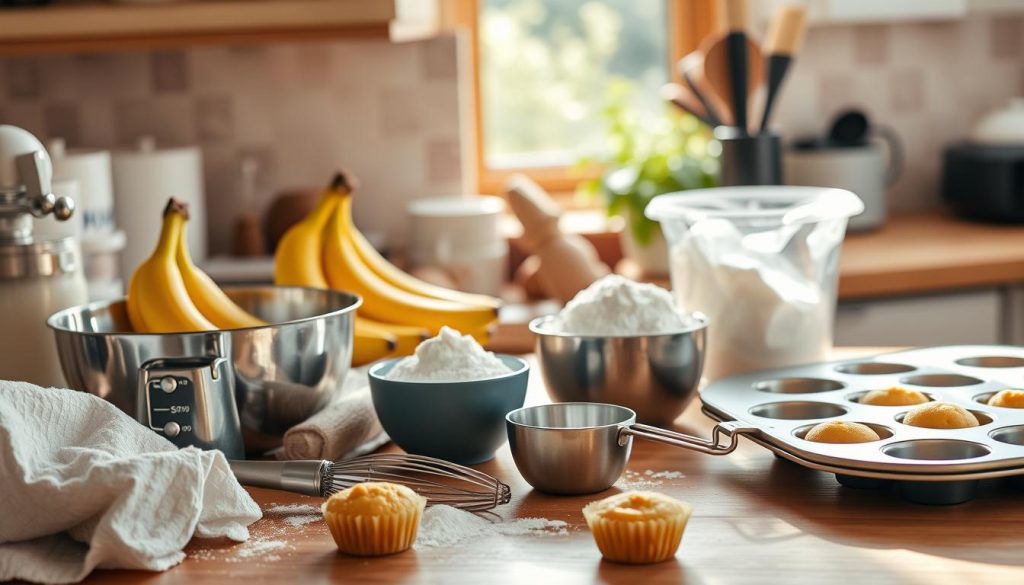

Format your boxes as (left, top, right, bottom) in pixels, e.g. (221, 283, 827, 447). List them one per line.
(324, 499, 426, 556)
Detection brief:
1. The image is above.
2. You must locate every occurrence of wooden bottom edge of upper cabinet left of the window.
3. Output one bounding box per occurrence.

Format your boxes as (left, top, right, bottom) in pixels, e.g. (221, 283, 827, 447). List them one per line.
(0, 0, 431, 54)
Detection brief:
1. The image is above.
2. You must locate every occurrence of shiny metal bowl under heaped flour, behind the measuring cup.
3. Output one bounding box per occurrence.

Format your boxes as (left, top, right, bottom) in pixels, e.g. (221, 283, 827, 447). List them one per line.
(529, 315, 708, 425)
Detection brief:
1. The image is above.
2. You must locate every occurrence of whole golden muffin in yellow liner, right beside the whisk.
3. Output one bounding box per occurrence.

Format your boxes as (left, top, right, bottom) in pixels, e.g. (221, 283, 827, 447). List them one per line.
(321, 482, 427, 556)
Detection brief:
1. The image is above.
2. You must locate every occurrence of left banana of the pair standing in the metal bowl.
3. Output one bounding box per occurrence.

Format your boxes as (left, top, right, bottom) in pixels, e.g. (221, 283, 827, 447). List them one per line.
(128, 199, 217, 333)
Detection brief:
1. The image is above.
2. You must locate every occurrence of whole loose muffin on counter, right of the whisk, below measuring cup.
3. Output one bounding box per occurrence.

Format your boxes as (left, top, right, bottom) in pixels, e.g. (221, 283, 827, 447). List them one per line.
(583, 492, 691, 565)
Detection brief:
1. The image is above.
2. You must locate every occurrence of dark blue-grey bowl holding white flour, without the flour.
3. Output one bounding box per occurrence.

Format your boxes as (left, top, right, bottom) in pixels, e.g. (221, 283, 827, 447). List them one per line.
(370, 354, 529, 465)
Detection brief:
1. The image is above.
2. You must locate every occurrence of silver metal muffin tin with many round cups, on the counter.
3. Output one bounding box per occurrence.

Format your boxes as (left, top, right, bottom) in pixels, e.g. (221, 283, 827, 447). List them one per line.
(700, 345, 1024, 504)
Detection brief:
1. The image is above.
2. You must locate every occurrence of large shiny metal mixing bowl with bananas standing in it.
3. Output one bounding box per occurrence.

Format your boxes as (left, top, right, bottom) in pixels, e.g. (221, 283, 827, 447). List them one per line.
(48, 286, 361, 453)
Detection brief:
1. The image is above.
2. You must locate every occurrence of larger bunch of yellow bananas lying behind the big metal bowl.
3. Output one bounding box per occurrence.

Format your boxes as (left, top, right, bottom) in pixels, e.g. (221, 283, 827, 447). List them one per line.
(273, 173, 500, 366)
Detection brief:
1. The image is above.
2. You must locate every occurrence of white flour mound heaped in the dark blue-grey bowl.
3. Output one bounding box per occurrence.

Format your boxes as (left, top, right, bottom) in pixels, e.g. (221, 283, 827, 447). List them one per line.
(385, 327, 511, 382)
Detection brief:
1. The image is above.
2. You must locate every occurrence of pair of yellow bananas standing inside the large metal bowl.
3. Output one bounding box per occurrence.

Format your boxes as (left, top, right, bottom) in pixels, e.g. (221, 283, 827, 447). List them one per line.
(127, 199, 266, 333)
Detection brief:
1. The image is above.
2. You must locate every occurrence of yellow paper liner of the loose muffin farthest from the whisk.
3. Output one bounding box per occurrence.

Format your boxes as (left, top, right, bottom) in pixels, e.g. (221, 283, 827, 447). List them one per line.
(583, 502, 690, 565)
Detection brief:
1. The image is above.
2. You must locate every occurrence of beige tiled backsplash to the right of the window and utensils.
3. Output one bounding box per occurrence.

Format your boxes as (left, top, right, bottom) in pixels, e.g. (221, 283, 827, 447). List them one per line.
(775, 15, 1024, 209)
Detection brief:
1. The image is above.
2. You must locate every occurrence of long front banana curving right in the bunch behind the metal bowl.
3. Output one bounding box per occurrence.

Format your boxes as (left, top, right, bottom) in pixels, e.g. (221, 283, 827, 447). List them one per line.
(324, 196, 498, 333)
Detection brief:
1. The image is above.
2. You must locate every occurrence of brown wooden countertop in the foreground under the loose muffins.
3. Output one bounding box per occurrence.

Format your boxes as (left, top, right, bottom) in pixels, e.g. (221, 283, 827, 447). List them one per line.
(87, 350, 1024, 585)
